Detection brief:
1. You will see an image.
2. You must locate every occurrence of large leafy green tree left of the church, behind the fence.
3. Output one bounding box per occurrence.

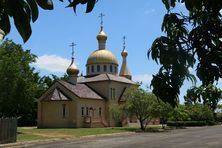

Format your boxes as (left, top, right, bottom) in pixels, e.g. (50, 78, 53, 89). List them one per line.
(0, 40, 39, 119)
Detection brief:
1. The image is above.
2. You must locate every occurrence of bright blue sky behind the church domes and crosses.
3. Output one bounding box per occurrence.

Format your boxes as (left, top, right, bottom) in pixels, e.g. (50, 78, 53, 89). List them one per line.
(3, 0, 222, 102)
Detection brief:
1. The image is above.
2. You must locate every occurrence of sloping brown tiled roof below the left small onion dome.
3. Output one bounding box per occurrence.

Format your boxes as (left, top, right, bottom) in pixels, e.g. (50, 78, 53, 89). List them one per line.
(58, 81, 103, 99)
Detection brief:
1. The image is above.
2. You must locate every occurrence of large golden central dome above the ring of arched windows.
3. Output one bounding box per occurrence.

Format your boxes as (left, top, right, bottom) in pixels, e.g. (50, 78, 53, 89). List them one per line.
(87, 49, 118, 65)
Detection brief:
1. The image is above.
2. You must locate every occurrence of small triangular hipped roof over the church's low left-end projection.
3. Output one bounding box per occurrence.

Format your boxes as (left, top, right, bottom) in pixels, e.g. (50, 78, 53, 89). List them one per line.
(43, 87, 71, 101)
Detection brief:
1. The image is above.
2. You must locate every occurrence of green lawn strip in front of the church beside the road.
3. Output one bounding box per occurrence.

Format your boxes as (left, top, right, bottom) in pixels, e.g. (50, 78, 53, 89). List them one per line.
(17, 127, 139, 141)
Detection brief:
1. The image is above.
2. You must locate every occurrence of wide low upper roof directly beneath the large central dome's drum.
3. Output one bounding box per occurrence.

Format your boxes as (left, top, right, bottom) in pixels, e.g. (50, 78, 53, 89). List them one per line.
(77, 73, 136, 84)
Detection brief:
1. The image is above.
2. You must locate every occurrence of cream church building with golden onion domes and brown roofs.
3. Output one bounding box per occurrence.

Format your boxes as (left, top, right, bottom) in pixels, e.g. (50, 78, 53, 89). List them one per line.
(38, 19, 136, 128)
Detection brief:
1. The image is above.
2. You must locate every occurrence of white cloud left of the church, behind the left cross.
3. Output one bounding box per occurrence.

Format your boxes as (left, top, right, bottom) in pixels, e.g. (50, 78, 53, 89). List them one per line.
(33, 54, 71, 72)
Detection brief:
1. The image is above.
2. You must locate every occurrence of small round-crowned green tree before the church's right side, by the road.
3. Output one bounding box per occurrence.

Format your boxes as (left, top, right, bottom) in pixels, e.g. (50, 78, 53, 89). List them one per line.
(125, 86, 158, 131)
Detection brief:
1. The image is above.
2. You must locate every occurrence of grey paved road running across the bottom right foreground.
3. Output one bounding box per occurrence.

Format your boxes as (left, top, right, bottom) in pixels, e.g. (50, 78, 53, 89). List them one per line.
(23, 126, 222, 148)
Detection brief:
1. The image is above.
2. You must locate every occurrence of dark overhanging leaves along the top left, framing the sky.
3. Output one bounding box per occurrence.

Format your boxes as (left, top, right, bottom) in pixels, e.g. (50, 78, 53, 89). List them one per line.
(0, 0, 97, 42)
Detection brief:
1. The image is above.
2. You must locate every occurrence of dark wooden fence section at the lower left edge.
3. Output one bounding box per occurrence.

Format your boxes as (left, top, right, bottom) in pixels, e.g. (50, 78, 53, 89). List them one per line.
(0, 118, 17, 144)
